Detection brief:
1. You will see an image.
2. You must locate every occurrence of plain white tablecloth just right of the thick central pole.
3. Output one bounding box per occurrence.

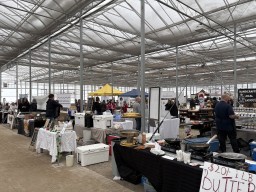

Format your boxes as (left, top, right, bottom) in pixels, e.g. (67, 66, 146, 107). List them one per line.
(150, 118, 180, 139)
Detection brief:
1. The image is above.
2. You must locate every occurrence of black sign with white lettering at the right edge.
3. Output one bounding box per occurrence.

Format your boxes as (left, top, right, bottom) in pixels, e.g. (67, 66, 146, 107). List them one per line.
(238, 89, 256, 104)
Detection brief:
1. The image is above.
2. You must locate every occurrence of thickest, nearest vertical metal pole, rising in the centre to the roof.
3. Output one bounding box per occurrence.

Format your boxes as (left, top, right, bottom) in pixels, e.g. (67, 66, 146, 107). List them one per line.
(140, 0, 145, 132)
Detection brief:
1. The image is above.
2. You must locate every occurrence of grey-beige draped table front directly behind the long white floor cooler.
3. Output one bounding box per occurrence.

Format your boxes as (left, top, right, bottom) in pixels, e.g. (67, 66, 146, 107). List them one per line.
(91, 128, 119, 143)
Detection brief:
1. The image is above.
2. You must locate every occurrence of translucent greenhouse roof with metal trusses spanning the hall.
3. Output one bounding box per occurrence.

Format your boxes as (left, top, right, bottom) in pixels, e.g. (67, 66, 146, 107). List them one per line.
(0, 0, 256, 91)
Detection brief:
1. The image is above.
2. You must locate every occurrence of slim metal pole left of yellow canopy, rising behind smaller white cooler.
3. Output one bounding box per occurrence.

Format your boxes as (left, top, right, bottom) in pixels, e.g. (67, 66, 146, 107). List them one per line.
(79, 11, 84, 112)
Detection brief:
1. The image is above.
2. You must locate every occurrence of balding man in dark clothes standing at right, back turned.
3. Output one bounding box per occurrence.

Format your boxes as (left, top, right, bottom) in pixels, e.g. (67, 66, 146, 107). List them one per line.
(214, 94, 240, 153)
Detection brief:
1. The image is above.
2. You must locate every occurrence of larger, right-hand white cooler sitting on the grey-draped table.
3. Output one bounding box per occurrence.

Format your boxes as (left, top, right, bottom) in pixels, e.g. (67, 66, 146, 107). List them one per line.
(92, 115, 113, 129)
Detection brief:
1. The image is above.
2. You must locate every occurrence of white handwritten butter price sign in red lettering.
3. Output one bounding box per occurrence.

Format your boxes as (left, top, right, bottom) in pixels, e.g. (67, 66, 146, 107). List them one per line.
(200, 162, 256, 192)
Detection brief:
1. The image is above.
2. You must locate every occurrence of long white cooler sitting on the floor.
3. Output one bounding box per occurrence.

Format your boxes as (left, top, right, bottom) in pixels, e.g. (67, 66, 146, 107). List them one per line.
(76, 143, 109, 166)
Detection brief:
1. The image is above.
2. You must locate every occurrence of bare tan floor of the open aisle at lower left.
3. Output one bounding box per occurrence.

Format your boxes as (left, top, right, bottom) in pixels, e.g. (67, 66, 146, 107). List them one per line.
(0, 124, 144, 192)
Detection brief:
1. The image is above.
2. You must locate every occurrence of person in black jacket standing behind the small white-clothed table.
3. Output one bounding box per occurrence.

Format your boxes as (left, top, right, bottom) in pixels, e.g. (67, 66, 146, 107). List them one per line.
(46, 94, 63, 120)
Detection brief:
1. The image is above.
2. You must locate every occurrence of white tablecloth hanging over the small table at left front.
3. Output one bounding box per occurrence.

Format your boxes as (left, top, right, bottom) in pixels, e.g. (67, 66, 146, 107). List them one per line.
(36, 128, 77, 162)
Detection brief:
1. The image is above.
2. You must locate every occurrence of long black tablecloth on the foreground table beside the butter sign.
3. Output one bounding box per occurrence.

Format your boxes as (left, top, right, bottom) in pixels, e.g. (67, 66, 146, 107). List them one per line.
(113, 142, 202, 192)
